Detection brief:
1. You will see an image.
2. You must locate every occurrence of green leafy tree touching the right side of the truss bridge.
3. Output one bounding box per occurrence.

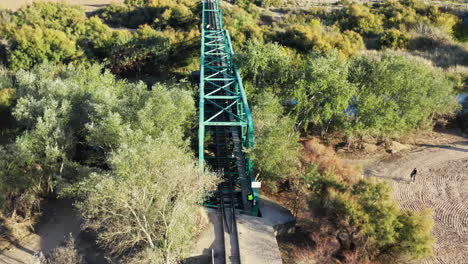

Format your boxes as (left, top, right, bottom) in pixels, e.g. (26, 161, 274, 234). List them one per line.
(249, 93, 300, 186)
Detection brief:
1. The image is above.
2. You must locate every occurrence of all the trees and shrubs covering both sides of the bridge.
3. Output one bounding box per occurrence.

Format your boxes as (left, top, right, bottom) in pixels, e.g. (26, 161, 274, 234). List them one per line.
(0, 0, 468, 263)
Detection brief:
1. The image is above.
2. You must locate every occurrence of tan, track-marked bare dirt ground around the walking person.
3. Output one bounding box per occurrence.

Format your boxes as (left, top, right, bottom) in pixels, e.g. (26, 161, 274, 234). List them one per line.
(360, 137, 468, 264)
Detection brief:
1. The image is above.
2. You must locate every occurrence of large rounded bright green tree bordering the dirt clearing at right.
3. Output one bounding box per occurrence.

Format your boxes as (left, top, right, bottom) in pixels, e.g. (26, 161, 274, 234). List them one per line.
(349, 54, 458, 135)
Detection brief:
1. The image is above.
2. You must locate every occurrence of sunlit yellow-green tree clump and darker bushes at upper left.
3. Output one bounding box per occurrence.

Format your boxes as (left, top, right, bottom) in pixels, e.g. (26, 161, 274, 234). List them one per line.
(0, 3, 176, 76)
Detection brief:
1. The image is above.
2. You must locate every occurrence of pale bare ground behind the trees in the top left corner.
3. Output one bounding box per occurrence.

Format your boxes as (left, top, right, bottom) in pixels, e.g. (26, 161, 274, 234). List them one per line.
(0, 0, 123, 11)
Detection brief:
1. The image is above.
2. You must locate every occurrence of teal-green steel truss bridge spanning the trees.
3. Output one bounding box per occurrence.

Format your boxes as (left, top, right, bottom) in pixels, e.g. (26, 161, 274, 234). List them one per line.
(198, 0, 259, 219)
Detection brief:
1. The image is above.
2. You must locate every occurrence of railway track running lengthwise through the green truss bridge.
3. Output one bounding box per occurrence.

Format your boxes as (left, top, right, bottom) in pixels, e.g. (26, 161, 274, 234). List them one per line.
(203, 0, 245, 264)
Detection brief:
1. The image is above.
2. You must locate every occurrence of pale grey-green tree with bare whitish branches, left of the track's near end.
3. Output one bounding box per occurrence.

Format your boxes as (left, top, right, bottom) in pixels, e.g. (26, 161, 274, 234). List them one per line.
(78, 137, 215, 263)
